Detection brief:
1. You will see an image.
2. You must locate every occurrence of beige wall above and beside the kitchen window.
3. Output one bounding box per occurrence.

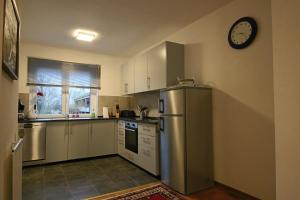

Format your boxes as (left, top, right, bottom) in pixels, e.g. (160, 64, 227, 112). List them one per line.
(19, 43, 126, 96)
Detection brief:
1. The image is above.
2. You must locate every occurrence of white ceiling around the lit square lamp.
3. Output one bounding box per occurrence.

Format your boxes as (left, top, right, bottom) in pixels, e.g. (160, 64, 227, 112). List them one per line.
(18, 0, 231, 56)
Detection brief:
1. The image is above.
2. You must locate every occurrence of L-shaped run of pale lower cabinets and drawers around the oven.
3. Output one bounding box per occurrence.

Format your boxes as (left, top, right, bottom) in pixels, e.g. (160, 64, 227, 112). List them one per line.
(46, 120, 159, 175)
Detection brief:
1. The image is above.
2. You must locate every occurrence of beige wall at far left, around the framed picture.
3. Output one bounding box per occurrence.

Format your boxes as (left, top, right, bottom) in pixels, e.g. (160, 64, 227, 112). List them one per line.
(0, 0, 18, 200)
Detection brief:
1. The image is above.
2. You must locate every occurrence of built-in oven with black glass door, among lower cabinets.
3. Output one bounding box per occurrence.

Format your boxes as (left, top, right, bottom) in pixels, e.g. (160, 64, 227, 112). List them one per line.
(125, 122, 138, 153)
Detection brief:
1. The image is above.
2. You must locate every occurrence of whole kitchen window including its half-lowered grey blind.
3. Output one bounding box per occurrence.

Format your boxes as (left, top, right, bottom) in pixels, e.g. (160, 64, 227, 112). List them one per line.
(27, 57, 101, 118)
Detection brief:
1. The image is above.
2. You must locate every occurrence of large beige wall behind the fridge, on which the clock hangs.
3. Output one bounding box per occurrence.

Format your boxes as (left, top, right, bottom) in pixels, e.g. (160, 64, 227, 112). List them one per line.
(130, 0, 275, 200)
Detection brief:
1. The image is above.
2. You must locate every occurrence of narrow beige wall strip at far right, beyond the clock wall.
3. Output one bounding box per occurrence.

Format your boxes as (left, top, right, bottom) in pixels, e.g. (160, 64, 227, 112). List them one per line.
(272, 0, 300, 200)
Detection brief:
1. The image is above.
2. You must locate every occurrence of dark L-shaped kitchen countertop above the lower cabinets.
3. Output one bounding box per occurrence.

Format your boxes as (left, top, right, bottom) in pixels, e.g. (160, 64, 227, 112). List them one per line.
(18, 116, 159, 124)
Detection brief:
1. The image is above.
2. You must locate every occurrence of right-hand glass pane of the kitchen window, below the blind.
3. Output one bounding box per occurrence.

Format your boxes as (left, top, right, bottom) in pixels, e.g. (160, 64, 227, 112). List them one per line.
(69, 87, 91, 114)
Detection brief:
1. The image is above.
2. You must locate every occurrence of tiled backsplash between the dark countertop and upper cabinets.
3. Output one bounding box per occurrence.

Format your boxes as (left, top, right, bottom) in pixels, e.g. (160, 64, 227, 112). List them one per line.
(19, 92, 159, 117)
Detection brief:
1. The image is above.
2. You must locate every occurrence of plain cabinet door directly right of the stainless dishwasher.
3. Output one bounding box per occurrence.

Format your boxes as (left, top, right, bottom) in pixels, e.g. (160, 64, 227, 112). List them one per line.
(46, 122, 69, 162)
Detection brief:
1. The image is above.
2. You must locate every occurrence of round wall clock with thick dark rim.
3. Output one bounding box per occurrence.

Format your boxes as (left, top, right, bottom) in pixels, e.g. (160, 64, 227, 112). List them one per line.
(228, 17, 257, 49)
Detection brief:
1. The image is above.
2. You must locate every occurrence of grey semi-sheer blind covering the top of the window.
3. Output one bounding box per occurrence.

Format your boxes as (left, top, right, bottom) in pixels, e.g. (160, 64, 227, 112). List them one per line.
(27, 57, 101, 89)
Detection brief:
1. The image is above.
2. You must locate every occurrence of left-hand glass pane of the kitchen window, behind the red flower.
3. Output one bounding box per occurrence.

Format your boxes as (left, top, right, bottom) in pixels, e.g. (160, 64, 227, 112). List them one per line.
(35, 86, 63, 115)
